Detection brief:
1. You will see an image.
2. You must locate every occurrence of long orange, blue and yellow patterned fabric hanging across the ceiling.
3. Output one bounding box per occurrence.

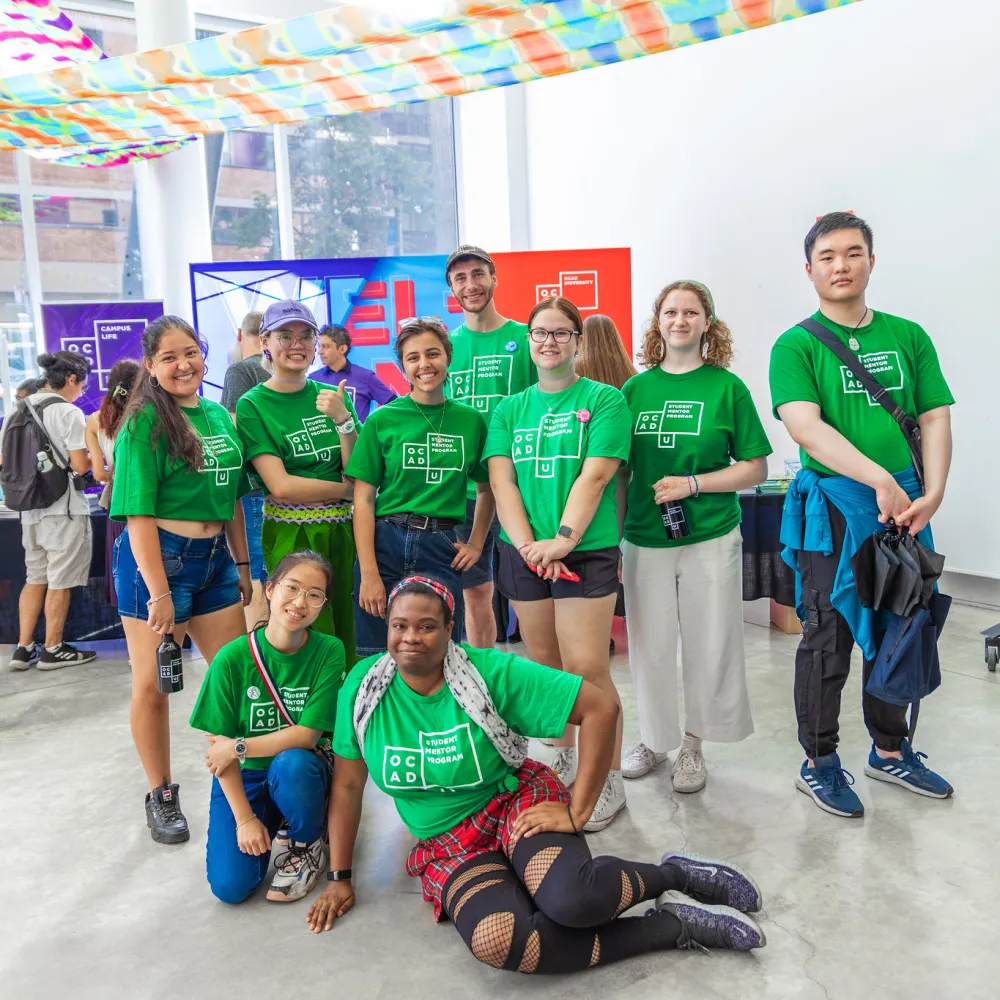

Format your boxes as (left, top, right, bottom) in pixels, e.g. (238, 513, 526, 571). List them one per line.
(0, 0, 859, 156)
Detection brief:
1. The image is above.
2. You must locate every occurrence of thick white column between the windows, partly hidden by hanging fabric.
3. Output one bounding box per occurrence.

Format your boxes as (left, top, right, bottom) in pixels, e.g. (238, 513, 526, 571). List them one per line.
(135, 0, 212, 320)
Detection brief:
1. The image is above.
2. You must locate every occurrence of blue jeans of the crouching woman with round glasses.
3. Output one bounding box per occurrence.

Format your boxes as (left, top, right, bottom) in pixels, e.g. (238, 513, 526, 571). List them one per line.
(205, 749, 329, 903)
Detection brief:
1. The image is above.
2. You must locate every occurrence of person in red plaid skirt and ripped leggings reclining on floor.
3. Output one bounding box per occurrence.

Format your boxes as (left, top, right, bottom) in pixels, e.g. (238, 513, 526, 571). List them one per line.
(306, 577, 764, 972)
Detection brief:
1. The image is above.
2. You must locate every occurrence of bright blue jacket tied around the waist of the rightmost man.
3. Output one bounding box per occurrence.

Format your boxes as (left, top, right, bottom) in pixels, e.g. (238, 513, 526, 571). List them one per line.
(781, 466, 934, 660)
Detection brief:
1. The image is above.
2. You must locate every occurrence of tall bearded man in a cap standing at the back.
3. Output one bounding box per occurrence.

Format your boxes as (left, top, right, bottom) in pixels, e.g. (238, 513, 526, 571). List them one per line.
(445, 244, 538, 647)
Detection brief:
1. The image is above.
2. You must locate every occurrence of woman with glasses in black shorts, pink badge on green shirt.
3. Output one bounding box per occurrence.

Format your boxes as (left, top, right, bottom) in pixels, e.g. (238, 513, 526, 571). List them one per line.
(485, 298, 629, 831)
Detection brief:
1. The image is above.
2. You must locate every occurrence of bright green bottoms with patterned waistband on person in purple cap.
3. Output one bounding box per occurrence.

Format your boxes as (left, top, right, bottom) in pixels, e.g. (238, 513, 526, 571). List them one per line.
(260, 500, 357, 670)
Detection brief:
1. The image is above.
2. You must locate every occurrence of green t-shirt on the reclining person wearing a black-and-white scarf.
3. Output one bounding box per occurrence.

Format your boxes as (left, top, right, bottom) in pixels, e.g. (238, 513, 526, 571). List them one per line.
(334, 644, 581, 839)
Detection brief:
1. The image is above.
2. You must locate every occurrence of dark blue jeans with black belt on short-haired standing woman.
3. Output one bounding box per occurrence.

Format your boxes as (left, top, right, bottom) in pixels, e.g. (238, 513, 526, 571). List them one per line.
(354, 518, 465, 659)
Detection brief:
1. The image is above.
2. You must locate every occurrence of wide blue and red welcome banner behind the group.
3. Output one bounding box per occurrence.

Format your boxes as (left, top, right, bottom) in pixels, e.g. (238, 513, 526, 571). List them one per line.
(191, 249, 632, 400)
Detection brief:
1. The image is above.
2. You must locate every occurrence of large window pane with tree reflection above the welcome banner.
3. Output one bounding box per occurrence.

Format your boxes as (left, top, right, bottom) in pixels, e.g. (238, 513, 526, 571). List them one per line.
(288, 100, 458, 257)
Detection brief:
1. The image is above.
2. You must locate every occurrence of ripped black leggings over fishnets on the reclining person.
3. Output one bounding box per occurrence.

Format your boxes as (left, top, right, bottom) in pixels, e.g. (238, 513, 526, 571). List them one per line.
(443, 833, 684, 973)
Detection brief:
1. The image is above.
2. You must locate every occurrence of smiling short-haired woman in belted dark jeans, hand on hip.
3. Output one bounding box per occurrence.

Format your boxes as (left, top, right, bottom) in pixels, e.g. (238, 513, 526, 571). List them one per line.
(345, 317, 496, 656)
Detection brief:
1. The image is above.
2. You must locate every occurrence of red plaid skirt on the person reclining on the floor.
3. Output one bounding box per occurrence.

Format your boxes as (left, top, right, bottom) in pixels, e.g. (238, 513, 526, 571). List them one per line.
(406, 760, 569, 921)
